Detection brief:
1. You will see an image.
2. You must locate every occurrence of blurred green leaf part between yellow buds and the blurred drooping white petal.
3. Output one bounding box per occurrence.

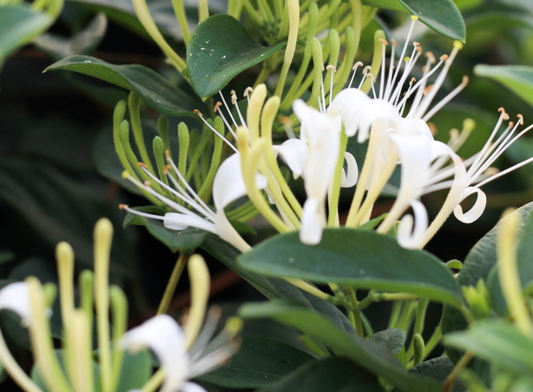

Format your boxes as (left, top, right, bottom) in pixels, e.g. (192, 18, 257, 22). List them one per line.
(116, 350, 152, 392)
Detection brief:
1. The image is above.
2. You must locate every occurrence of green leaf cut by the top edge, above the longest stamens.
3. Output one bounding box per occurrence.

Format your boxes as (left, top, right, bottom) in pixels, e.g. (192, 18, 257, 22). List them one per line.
(363, 0, 466, 42)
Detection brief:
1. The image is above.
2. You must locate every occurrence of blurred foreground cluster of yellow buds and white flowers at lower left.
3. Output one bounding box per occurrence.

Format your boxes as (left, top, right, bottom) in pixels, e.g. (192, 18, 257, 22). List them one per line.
(0, 219, 241, 392)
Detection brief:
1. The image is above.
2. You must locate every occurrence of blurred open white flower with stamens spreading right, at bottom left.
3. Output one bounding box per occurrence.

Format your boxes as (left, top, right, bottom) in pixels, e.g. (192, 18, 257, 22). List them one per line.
(119, 314, 236, 392)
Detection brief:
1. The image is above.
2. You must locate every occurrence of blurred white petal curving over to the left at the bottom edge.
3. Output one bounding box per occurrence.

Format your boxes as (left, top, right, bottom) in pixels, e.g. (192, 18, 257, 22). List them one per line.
(119, 314, 189, 392)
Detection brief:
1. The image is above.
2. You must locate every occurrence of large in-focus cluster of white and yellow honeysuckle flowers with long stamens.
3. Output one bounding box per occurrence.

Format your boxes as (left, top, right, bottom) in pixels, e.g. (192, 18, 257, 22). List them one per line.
(120, 17, 533, 251)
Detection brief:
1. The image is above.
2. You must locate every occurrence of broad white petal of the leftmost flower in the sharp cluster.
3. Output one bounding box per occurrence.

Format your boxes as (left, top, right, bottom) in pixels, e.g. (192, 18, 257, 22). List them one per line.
(213, 153, 266, 211)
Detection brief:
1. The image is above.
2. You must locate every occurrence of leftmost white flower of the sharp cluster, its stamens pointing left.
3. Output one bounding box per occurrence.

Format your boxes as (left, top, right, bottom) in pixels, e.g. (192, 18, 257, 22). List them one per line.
(121, 152, 266, 251)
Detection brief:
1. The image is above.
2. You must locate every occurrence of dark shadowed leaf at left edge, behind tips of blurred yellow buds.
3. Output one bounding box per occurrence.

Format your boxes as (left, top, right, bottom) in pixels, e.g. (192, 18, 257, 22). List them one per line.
(0, 157, 135, 276)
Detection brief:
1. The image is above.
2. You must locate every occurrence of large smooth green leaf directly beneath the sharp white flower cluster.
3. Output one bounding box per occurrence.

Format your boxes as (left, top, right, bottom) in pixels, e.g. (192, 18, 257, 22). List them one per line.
(238, 228, 461, 306)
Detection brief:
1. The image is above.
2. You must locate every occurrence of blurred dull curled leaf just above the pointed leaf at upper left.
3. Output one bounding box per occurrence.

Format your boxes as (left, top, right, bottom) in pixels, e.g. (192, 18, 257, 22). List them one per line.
(35, 13, 107, 61)
